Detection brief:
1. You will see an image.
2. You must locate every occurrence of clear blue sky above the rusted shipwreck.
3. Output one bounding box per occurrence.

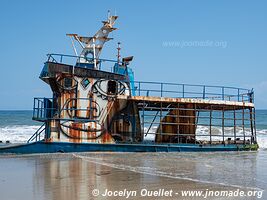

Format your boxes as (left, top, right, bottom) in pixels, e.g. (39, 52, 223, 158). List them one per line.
(0, 0, 267, 110)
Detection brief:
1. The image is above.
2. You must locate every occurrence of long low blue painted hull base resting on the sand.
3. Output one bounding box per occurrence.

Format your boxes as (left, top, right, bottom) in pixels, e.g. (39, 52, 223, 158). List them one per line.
(0, 141, 256, 154)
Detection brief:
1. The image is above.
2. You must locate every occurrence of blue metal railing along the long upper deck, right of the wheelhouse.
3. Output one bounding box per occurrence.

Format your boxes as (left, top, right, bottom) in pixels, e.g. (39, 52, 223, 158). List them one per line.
(134, 81, 254, 102)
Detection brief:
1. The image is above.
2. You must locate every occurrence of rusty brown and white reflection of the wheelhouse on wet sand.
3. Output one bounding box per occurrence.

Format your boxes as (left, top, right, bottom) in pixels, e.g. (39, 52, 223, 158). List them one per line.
(34, 159, 92, 199)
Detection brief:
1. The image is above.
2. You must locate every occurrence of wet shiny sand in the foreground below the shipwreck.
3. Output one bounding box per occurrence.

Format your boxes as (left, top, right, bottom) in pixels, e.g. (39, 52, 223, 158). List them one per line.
(0, 153, 266, 200)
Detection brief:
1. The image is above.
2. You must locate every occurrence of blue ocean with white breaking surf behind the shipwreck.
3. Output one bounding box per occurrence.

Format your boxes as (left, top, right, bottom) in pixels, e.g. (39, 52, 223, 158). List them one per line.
(0, 110, 267, 149)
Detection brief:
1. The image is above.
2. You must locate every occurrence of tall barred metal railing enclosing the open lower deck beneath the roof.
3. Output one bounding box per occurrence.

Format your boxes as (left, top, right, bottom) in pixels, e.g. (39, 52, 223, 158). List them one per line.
(138, 100, 256, 144)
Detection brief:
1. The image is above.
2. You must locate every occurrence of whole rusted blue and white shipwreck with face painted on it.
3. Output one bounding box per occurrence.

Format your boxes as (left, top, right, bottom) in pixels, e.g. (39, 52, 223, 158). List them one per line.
(0, 16, 258, 153)
